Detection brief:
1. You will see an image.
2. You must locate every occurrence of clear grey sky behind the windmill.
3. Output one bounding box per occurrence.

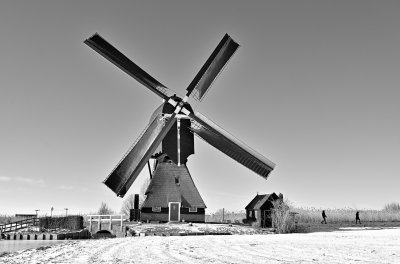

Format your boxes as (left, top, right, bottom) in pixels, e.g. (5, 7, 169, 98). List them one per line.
(0, 0, 400, 214)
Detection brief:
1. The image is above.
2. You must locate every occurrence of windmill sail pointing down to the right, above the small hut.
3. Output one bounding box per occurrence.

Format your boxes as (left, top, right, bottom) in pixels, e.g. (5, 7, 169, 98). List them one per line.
(190, 113, 275, 179)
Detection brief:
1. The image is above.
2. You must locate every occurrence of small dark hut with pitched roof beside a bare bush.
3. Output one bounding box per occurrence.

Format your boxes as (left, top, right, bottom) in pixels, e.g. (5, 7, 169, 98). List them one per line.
(245, 193, 283, 228)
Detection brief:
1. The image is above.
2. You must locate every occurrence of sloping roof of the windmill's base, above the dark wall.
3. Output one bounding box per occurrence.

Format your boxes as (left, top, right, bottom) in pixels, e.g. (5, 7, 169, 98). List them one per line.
(143, 157, 206, 208)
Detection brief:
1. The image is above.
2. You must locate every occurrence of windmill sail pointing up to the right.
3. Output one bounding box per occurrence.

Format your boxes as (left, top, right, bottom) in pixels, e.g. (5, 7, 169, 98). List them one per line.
(186, 34, 239, 101)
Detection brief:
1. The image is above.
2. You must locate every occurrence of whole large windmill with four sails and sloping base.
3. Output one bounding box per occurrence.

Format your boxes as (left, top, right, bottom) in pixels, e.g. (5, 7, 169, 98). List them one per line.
(84, 33, 275, 222)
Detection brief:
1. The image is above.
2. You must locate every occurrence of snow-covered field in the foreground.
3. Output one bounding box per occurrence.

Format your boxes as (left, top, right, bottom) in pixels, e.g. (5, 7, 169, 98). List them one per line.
(0, 228, 400, 264)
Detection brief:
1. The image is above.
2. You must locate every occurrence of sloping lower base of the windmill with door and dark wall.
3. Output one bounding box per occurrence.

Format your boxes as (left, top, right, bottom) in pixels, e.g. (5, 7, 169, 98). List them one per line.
(140, 154, 206, 222)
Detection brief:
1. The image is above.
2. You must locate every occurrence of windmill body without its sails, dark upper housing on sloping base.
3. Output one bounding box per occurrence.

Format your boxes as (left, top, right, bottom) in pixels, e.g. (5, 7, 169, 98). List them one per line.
(140, 96, 206, 222)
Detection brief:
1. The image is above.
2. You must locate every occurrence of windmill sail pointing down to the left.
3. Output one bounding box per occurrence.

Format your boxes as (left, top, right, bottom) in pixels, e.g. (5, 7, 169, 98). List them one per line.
(103, 108, 176, 197)
